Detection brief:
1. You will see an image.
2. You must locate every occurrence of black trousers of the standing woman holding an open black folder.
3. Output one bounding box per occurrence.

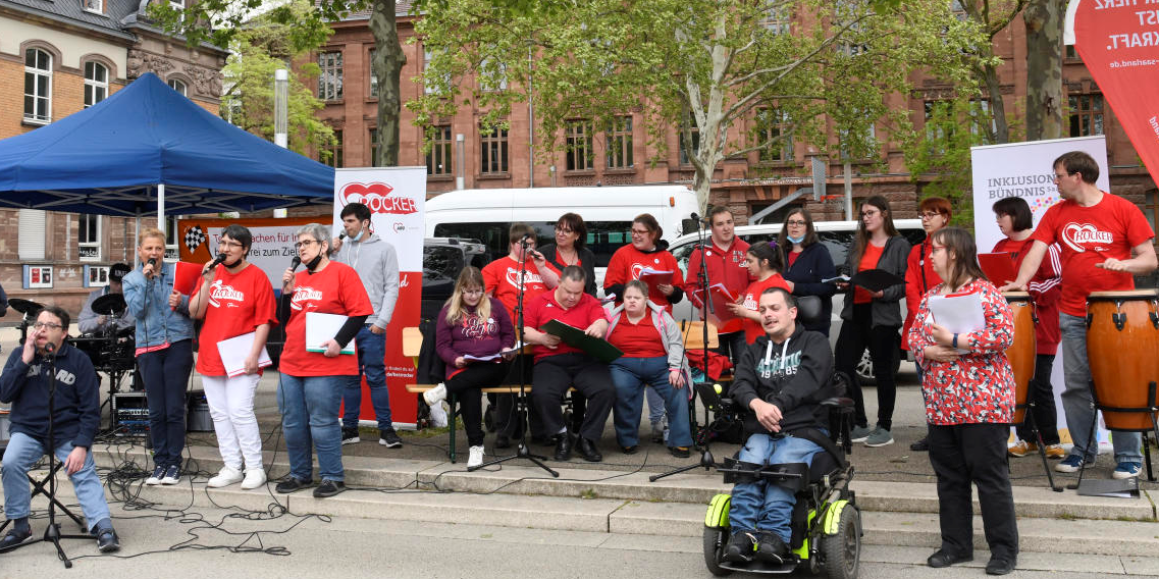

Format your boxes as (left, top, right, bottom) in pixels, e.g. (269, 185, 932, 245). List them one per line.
(834, 303, 898, 430)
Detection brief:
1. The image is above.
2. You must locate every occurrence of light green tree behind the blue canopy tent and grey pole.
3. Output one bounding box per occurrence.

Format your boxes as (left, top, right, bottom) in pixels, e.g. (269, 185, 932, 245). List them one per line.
(221, 0, 335, 156)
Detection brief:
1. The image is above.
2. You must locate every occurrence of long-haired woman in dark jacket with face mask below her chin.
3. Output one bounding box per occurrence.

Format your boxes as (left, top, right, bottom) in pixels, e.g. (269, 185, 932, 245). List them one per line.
(777, 207, 837, 336)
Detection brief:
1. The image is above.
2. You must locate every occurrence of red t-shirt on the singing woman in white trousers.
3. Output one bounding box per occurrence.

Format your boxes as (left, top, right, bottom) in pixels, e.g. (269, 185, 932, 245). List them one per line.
(189, 264, 278, 376)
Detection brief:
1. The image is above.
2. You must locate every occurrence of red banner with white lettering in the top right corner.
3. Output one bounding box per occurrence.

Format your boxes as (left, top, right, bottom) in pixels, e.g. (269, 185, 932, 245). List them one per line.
(1074, 0, 1159, 183)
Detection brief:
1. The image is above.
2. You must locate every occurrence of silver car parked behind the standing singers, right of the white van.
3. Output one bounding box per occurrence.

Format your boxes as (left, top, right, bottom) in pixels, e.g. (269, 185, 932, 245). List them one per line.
(670, 219, 926, 384)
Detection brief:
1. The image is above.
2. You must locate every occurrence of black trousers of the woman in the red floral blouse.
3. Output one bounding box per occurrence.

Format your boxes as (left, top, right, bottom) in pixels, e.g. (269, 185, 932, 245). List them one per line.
(930, 424, 1018, 558)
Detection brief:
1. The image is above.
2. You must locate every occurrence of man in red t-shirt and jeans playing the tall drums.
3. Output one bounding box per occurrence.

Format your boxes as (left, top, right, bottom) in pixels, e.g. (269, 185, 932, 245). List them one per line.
(1003, 151, 1156, 478)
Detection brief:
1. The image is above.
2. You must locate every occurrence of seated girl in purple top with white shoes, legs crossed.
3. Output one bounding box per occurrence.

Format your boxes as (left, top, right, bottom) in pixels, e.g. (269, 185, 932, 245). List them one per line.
(423, 266, 515, 468)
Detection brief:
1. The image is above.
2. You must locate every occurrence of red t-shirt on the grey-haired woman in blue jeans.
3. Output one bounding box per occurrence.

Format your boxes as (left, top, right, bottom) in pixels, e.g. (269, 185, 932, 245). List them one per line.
(278, 262, 374, 376)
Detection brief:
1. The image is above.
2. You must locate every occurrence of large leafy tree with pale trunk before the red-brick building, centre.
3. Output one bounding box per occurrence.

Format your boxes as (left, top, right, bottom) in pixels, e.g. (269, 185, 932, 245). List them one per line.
(407, 0, 987, 208)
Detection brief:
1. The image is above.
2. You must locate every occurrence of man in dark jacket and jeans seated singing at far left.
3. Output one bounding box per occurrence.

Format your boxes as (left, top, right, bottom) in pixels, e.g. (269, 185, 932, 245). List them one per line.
(0, 307, 121, 552)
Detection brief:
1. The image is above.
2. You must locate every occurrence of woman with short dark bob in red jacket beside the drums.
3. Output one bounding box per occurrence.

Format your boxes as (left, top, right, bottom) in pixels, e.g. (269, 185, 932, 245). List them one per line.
(993, 197, 1066, 460)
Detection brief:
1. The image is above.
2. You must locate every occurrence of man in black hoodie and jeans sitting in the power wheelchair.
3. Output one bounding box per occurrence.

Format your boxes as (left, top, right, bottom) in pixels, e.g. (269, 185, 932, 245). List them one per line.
(724, 287, 833, 564)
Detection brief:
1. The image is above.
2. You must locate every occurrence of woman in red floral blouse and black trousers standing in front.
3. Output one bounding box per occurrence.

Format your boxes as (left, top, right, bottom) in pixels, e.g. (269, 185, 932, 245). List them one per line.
(909, 227, 1019, 574)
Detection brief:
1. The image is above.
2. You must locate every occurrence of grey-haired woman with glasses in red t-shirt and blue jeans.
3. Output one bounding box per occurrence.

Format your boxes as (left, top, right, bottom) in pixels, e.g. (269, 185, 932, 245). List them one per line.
(275, 223, 374, 498)
